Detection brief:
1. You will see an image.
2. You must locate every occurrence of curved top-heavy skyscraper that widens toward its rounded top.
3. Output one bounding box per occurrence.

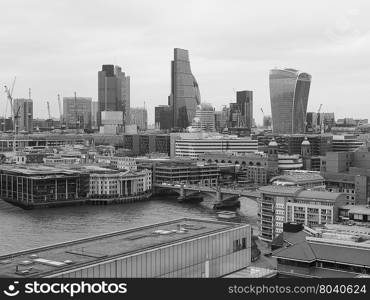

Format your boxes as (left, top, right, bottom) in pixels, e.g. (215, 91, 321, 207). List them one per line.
(270, 69, 311, 134)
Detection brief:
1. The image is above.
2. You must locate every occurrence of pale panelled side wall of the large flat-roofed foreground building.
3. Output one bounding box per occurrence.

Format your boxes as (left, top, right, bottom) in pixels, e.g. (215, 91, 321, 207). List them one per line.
(55, 225, 251, 278)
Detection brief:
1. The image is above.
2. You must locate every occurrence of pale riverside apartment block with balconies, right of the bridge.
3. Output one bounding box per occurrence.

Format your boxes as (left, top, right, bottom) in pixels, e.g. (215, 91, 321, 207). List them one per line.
(258, 185, 346, 242)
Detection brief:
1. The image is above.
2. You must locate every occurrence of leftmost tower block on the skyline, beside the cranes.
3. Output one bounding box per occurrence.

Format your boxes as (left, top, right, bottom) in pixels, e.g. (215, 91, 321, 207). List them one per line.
(13, 98, 33, 132)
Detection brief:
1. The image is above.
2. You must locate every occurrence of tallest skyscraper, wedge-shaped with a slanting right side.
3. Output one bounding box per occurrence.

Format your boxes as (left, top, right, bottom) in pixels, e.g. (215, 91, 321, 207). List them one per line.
(168, 48, 200, 128)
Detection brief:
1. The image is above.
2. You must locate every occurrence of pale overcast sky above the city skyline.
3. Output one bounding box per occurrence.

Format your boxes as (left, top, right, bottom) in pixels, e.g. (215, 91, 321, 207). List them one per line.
(0, 0, 370, 123)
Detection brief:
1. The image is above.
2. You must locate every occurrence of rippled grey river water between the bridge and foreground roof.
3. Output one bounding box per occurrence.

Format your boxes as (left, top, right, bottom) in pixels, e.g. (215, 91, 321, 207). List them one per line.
(0, 197, 257, 255)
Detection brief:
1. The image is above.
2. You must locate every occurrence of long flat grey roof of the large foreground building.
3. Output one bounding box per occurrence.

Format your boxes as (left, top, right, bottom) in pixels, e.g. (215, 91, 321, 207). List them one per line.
(0, 218, 247, 278)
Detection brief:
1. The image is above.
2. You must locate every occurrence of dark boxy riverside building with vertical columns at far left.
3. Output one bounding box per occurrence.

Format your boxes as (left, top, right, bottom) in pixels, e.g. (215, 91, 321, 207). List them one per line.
(0, 165, 89, 208)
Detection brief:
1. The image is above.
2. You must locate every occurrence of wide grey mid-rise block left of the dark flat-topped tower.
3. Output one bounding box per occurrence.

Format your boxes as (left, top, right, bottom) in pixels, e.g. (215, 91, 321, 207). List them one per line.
(63, 97, 92, 129)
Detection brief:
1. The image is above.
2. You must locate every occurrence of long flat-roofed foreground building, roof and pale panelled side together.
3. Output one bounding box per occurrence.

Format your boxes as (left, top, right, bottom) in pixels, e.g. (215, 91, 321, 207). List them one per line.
(0, 218, 251, 278)
